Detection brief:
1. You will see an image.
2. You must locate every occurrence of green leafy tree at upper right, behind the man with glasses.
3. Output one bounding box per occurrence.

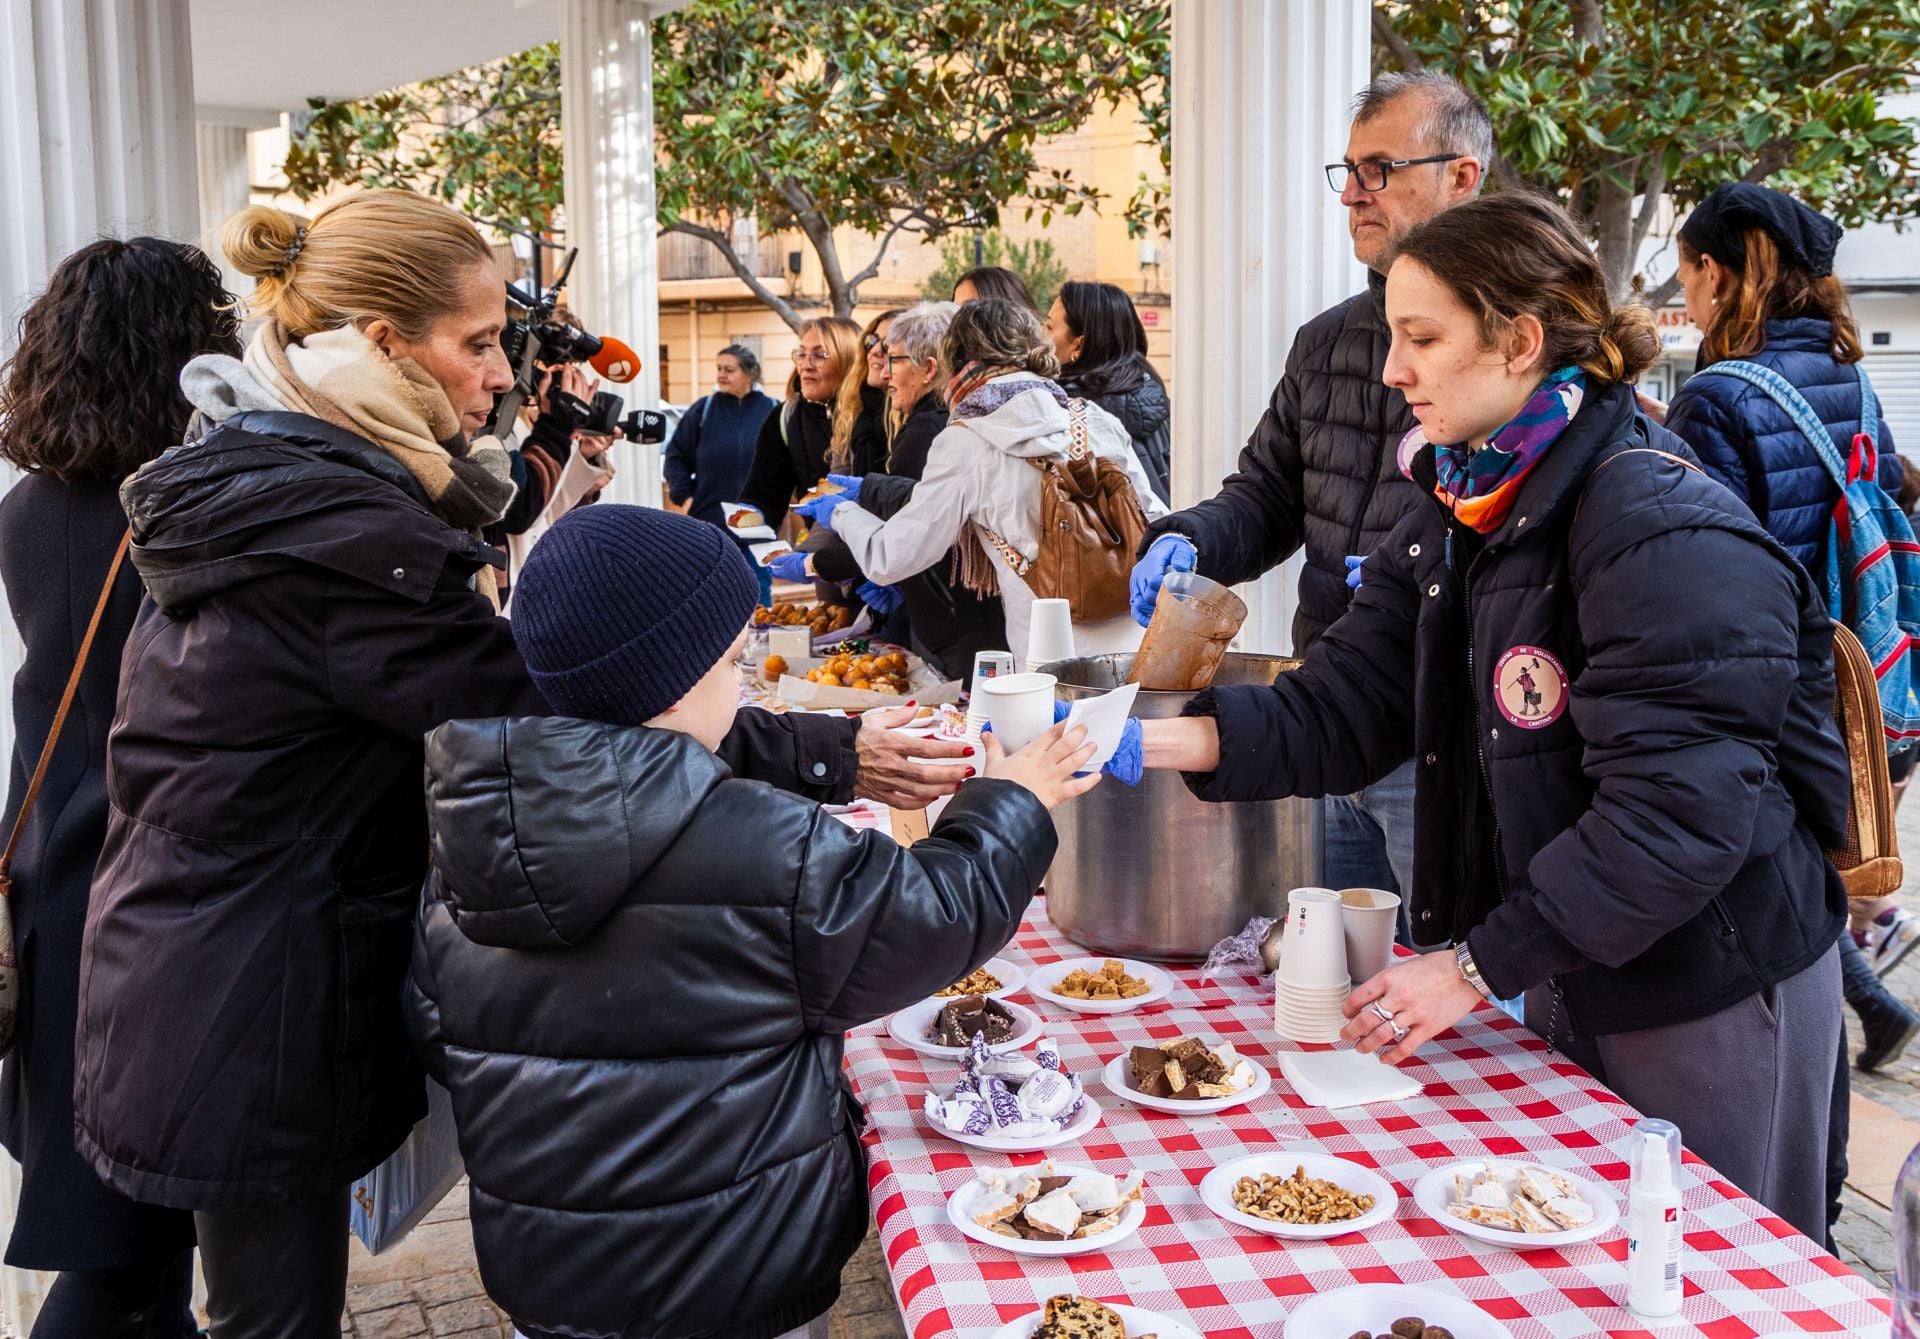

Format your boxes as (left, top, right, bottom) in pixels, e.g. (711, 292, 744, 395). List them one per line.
(1373, 0, 1920, 305)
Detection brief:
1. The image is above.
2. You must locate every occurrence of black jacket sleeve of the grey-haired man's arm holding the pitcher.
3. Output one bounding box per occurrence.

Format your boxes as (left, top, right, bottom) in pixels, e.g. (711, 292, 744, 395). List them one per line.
(1140, 355, 1306, 586)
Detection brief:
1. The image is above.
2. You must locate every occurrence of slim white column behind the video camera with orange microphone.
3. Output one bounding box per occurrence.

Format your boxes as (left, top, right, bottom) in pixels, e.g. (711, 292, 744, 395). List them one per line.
(561, 0, 660, 507)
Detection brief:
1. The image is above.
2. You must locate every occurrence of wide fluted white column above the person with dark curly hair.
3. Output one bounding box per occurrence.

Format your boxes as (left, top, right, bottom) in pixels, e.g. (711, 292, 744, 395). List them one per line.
(0, 0, 200, 353)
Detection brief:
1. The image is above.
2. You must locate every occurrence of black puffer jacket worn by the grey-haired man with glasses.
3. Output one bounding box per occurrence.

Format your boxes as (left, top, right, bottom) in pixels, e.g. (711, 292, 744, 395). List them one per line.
(1140, 275, 1419, 655)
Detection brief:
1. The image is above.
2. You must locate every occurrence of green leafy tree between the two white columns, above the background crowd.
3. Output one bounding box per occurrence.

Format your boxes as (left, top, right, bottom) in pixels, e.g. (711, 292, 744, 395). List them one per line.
(653, 0, 1171, 327)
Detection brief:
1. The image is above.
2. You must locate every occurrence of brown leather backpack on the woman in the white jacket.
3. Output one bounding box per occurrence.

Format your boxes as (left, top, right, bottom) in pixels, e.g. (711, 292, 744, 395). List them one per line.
(981, 400, 1146, 622)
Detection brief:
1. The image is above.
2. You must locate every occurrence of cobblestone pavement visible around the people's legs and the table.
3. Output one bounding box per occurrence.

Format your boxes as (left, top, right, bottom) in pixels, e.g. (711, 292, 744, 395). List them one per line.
(342, 799, 1920, 1339)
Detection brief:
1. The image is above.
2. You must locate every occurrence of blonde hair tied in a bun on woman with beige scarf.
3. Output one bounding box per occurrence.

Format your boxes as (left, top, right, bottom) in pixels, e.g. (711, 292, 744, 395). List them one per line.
(221, 190, 493, 340)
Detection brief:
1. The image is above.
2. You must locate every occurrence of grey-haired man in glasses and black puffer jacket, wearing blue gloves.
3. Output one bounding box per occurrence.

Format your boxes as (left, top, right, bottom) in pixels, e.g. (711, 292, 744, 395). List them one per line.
(1131, 71, 1494, 941)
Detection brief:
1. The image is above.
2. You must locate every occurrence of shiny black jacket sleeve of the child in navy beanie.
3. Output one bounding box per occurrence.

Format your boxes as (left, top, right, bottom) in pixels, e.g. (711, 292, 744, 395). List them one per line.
(793, 778, 1058, 1032)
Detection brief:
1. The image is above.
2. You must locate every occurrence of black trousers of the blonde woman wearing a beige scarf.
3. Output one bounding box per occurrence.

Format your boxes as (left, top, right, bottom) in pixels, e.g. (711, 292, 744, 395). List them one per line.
(194, 1185, 348, 1339)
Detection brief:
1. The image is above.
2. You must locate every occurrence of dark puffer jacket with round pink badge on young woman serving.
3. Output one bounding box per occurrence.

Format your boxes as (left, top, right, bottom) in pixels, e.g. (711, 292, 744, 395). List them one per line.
(1192, 386, 1849, 1035)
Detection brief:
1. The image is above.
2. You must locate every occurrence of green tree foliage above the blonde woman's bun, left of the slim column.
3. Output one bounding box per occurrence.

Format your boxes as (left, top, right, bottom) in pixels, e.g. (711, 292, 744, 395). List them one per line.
(286, 42, 563, 232)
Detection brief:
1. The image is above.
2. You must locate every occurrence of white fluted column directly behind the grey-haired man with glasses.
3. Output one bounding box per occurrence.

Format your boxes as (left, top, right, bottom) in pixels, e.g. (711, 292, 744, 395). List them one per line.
(1173, 0, 1371, 653)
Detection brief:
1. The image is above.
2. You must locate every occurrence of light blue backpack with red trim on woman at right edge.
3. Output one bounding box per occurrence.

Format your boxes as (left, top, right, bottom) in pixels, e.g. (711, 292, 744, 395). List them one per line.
(1695, 361, 1920, 753)
